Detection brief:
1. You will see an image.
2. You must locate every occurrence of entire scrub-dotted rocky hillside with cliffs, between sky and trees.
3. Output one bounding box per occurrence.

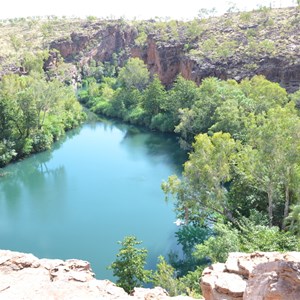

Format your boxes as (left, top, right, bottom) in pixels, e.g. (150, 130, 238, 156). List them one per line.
(0, 7, 300, 92)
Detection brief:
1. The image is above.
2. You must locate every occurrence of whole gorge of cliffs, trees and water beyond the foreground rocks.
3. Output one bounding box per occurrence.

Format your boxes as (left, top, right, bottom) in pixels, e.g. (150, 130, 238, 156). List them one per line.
(0, 7, 300, 299)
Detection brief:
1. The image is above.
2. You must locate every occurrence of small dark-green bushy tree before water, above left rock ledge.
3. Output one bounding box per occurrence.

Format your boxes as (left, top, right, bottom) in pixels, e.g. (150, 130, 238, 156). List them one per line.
(108, 236, 151, 293)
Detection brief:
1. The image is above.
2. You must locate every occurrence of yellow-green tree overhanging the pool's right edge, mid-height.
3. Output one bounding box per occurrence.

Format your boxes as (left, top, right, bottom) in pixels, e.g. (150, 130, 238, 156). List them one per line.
(162, 132, 240, 223)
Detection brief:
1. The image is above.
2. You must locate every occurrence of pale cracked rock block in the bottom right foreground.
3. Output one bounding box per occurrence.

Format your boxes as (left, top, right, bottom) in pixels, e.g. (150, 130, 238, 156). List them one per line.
(201, 252, 300, 300)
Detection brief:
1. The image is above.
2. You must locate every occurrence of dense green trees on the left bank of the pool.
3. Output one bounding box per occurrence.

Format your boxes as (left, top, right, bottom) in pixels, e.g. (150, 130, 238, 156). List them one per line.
(0, 55, 84, 167)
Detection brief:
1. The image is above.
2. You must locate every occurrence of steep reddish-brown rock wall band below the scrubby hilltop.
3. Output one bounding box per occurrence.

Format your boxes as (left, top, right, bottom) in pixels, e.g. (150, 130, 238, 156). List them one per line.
(50, 25, 300, 92)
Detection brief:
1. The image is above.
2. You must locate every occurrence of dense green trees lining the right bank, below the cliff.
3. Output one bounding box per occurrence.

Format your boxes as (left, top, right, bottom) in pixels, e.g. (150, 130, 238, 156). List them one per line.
(79, 58, 300, 294)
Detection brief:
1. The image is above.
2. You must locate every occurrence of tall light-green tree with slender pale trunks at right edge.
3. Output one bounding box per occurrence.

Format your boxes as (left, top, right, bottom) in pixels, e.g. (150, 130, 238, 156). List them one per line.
(237, 103, 300, 228)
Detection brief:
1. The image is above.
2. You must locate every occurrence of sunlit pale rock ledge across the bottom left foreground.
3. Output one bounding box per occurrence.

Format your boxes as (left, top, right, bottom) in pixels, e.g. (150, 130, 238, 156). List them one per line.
(0, 250, 192, 300)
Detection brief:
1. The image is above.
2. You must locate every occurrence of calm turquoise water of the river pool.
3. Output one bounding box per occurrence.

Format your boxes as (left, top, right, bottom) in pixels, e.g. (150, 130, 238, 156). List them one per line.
(0, 121, 186, 279)
